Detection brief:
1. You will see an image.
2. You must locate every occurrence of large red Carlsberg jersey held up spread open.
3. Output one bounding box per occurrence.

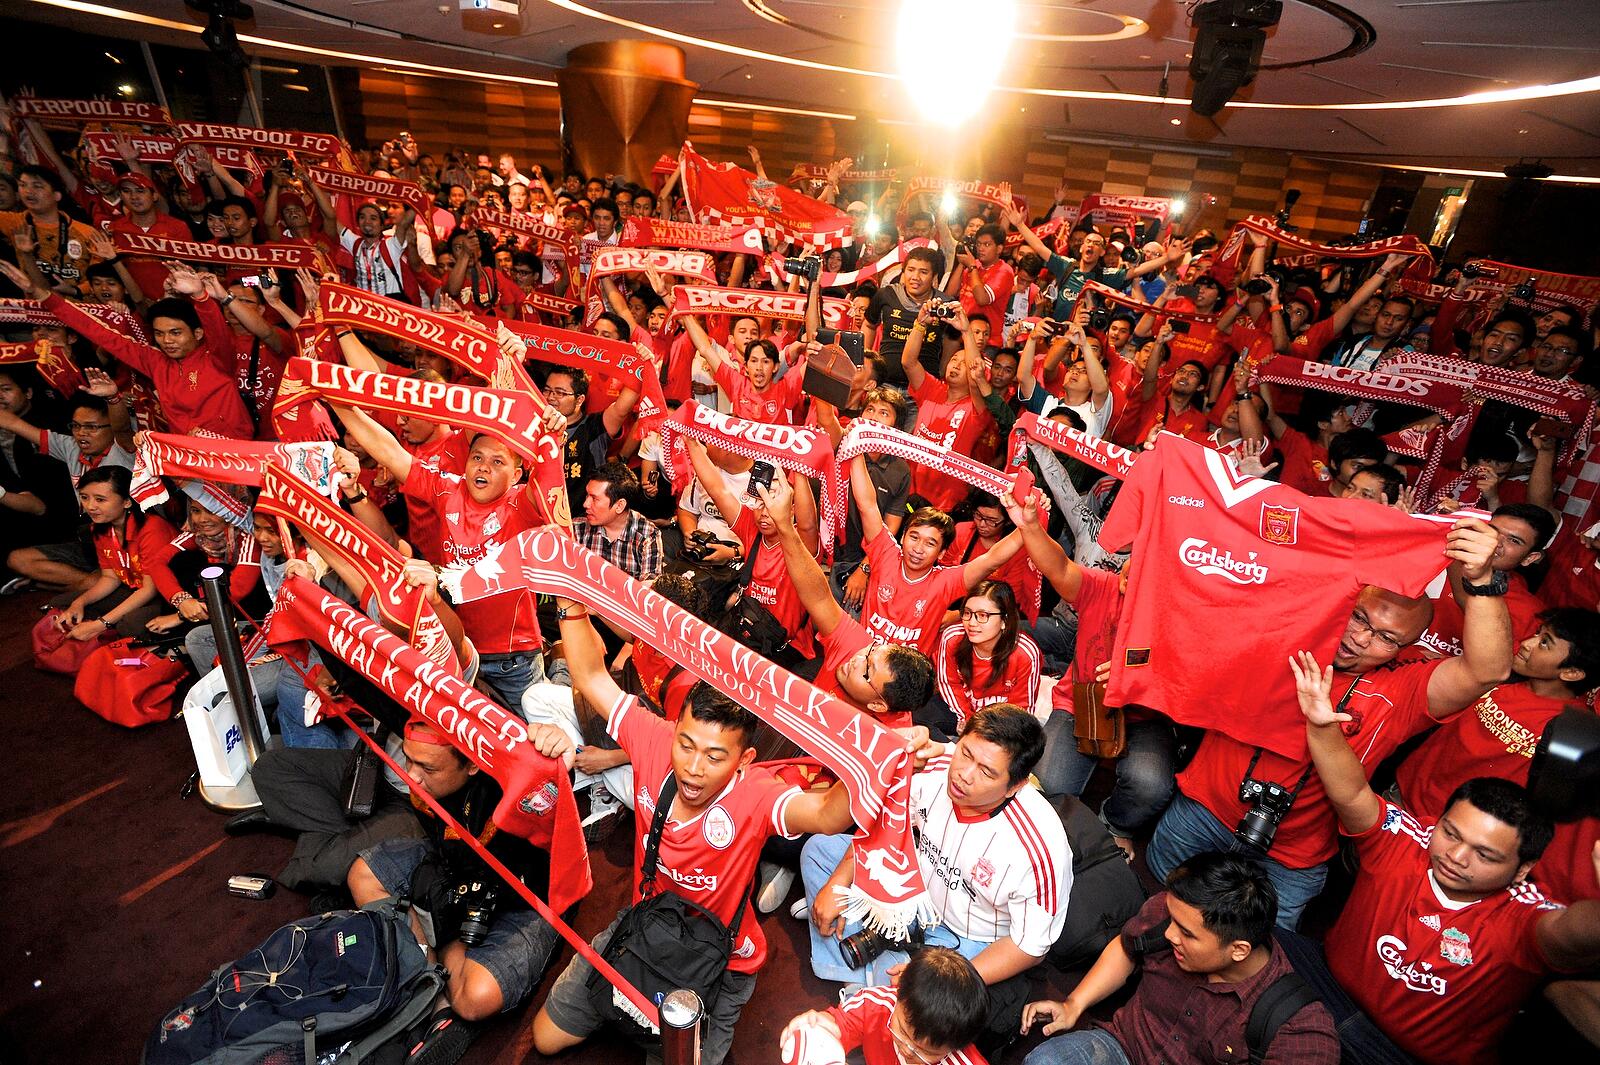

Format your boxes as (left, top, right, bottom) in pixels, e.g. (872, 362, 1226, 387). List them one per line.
(1099, 435, 1451, 754)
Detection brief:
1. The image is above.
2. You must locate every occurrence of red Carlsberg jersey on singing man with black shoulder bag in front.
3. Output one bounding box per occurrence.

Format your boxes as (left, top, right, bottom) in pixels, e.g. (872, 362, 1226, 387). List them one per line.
(606, 692, 800, 972)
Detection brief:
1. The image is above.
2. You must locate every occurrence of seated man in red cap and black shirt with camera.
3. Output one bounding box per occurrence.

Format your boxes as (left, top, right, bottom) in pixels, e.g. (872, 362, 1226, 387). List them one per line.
(346, 720, 571, 1060)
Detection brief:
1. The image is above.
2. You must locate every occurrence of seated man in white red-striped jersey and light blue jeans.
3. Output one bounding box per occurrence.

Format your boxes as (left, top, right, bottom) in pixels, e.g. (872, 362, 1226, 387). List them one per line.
(800, 704, 1072, 1033)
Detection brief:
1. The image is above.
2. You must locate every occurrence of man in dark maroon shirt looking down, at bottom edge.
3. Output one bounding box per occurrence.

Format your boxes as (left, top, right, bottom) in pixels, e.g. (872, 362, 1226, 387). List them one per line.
(1022, 851, 1339, 1065)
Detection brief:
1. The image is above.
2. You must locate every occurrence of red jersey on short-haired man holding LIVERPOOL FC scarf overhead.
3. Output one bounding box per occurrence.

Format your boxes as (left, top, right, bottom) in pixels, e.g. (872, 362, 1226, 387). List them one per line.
(400, 462, 544, 654)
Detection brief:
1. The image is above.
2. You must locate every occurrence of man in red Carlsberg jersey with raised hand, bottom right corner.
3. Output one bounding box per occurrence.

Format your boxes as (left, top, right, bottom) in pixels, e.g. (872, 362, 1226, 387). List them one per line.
(1285, 651, 1600, 1065)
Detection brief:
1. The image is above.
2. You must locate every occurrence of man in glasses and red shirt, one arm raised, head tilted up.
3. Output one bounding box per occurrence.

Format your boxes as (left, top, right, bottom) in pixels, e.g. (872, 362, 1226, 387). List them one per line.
(757, 478, 933, 729)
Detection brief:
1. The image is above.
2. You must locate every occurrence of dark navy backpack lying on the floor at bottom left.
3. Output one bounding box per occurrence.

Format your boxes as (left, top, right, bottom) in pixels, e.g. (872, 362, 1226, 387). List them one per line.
(141, 899, 445, 1065)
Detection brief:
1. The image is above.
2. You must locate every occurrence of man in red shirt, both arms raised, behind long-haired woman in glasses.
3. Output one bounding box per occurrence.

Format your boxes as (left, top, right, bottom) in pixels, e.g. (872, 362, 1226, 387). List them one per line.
(850, 456, 1022, 656)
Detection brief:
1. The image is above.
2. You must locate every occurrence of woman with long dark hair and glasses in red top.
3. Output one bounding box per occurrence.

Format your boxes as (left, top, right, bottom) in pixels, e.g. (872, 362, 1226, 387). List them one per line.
(934, 580, 1040, 736)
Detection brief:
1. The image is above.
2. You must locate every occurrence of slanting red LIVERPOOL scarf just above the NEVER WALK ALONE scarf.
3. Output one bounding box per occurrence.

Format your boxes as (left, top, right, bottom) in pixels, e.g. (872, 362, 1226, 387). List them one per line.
(256, 462, 461, 678)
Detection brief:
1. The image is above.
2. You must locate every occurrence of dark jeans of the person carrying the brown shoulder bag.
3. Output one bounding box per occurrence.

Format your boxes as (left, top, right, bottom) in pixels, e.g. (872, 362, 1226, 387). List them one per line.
(1035, 703, 1178, 840)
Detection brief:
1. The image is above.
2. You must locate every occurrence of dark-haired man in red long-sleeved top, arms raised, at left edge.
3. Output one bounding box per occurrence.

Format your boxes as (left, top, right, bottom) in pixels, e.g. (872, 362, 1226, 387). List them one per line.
(0, 262, 256, 440)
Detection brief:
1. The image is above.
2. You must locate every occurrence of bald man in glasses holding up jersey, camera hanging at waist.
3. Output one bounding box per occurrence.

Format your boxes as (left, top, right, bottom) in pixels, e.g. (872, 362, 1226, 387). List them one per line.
(1146, 518, 1512, 929)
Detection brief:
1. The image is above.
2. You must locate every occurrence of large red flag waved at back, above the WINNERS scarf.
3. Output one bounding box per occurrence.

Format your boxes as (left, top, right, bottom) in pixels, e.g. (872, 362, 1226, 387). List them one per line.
(680, 144, 854, 251)
